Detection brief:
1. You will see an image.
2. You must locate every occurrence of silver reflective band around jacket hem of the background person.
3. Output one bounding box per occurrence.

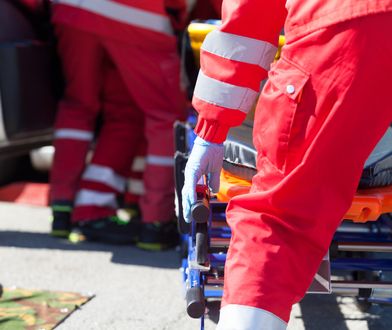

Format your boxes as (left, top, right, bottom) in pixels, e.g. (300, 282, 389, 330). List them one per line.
(56, 0, 173, 35)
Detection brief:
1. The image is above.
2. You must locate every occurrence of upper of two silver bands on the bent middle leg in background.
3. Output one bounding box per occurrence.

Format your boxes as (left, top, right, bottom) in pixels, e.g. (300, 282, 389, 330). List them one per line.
(82, 164, 126, 192)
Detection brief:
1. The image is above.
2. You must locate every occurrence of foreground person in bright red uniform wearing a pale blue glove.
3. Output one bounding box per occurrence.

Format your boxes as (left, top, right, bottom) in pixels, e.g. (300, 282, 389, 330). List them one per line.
(183, 0, 392, 330)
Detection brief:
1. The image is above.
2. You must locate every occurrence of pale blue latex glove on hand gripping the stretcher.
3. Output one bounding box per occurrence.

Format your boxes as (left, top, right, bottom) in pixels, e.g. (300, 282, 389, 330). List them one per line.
(182, 137, 224, 222)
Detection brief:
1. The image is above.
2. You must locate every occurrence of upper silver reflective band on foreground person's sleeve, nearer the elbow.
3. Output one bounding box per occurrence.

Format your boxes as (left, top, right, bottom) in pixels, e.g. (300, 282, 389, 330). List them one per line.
(201, 30, 278, 71)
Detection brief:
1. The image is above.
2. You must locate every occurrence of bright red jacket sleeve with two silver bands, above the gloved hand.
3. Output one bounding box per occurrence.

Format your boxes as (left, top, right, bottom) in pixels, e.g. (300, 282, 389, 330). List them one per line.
(193, 0, 287, 143)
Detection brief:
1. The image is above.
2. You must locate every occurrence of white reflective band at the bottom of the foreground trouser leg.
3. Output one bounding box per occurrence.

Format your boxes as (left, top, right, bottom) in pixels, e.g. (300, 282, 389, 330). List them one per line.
(216, 304, 287, 330)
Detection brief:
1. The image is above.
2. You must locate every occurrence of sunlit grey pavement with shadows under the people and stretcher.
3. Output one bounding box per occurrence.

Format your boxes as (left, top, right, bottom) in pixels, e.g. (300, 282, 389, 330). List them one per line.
(0, 203, 392, 330)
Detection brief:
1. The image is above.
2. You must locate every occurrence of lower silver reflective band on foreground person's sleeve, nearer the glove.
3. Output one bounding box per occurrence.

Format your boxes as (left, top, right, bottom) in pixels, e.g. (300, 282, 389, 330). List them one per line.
(194, 70, 258, 113)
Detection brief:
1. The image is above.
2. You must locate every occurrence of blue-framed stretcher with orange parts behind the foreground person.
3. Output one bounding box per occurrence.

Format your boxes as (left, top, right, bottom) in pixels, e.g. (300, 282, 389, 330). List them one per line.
(175, 23, 392, 329)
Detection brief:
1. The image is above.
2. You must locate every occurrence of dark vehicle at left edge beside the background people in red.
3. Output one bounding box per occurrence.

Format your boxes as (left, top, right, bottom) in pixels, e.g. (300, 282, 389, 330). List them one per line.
(0, 0, 61, 180)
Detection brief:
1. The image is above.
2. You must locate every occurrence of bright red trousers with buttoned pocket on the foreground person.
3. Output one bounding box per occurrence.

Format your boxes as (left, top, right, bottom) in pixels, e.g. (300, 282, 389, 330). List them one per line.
(222, 13, 392, 329)
